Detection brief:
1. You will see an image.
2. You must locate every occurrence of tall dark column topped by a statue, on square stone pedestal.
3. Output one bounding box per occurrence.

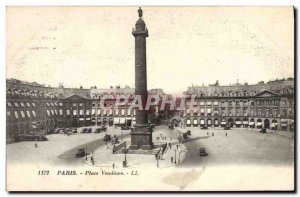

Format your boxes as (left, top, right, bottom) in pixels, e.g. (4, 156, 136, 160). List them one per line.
(130, 8, 153, 150)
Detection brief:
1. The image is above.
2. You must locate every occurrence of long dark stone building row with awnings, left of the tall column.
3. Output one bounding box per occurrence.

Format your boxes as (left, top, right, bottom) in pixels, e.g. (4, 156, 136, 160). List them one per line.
(6, 79, 164, 143)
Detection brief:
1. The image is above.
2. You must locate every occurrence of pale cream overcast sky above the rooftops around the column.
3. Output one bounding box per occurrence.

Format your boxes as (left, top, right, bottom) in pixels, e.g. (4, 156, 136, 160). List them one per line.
(7, 7, 294, 93)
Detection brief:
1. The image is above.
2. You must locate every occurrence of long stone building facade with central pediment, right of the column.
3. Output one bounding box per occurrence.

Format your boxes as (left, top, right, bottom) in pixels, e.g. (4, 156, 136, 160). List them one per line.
(173, 78, 295, 130)
